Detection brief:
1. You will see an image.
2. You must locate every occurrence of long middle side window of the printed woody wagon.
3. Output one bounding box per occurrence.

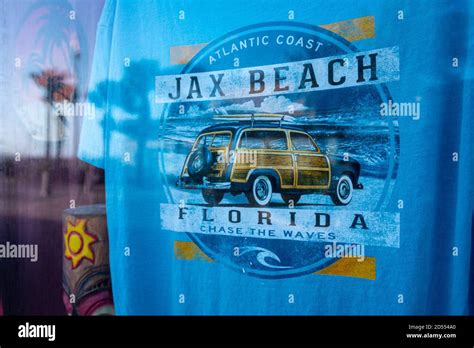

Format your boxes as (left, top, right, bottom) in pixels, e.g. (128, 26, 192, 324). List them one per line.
(239, 130, 288, 150)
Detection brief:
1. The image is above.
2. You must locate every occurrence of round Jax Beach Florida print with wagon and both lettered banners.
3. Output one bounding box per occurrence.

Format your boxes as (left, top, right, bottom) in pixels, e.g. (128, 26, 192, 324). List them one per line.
(155, 22, 400, 278)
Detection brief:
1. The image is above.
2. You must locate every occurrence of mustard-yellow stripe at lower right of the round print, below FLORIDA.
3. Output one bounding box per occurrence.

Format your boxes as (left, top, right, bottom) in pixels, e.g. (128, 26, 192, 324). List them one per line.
(314, 257, 376, 280)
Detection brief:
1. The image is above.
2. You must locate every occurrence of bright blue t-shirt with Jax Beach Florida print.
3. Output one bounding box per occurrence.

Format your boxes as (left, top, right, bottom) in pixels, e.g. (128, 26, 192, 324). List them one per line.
(79, 0, 474, 315)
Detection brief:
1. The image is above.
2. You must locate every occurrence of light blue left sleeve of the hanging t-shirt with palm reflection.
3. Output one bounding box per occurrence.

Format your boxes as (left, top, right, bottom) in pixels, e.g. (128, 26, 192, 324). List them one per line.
(77, 0, 115, 168)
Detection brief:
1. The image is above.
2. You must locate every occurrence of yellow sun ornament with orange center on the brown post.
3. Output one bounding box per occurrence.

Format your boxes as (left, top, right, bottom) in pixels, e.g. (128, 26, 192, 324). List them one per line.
(64, 219, 97, 269)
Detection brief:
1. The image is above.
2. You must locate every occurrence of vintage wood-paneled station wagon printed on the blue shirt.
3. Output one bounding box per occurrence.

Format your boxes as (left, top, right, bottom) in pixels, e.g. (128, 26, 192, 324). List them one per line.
(176, 114, 363, 206)
